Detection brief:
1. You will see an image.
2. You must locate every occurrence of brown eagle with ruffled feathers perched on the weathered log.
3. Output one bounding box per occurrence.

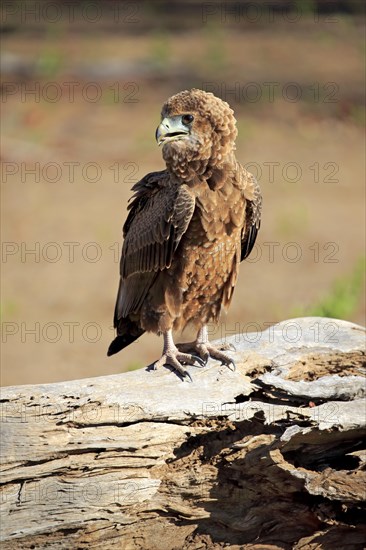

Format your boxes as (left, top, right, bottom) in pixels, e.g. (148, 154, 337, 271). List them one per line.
(108, 89, 262, 379)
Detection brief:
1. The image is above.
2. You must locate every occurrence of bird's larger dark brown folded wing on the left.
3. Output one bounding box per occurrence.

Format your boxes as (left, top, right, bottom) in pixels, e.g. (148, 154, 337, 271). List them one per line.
(114, 171, 195, 326)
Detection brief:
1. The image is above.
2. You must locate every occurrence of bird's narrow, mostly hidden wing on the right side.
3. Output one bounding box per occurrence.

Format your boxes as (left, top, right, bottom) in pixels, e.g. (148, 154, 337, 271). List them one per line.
(240, 167, 262, 261)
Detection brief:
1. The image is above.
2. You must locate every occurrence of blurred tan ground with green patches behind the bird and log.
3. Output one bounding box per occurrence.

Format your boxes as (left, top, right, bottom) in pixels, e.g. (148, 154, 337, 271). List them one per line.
(1, 0, 365, 385)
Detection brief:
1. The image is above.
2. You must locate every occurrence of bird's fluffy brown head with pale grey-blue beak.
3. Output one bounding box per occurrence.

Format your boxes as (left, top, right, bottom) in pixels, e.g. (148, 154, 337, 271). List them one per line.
(156, 89, 237, 179)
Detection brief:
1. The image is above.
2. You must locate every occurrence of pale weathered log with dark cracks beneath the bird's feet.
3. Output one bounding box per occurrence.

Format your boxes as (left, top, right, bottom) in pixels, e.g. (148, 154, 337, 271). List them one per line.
(1, 318, 366, 550)
